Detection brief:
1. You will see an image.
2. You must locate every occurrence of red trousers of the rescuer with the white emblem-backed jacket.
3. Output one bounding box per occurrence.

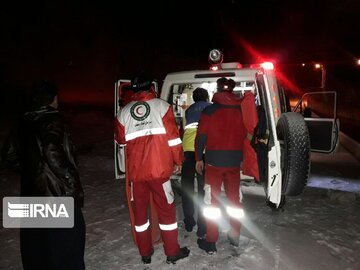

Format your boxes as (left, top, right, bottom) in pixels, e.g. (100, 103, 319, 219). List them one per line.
(133, 180, 180, 256)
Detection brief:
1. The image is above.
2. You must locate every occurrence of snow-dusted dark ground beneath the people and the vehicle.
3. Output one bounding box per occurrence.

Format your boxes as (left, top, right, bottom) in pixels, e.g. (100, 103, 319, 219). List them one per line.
(0, 108, 360, 270)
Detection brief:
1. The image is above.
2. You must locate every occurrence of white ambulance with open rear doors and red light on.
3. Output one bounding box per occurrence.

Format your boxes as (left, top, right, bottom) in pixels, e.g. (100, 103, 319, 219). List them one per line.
(114, 49, 339, 209)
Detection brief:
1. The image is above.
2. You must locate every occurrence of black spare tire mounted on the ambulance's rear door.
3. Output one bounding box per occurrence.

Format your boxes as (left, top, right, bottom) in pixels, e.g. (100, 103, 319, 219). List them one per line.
(276, 112, 310, 196)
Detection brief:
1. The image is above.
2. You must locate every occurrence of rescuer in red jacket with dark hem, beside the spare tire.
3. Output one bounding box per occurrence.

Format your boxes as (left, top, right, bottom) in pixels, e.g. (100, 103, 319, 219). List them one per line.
(195, 78, 255, 254)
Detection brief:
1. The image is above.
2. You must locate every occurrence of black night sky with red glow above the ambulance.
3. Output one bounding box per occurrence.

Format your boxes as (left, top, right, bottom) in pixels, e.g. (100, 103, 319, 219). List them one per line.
(0, 0, 360, 141)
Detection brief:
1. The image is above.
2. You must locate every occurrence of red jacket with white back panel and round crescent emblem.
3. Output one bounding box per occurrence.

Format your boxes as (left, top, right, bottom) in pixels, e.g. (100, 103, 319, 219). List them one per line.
(115, 91, 184, 181)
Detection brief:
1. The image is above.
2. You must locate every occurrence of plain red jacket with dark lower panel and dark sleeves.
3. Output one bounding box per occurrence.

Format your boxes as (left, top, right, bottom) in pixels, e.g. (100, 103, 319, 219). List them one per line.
(195, 91, 246, 168)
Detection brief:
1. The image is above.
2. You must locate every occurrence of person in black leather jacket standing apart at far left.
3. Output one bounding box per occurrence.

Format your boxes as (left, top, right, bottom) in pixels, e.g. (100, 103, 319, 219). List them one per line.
(18, 81, 85, 270)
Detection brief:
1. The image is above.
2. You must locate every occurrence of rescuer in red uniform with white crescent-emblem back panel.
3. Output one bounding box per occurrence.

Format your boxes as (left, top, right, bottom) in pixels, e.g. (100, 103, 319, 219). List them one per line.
(115, 73, 190, 264)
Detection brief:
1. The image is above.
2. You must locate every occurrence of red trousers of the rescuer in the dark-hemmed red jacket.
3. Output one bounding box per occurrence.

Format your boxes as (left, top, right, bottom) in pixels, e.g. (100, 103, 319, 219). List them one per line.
(204, 164, 242, 242)
